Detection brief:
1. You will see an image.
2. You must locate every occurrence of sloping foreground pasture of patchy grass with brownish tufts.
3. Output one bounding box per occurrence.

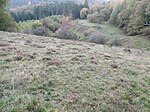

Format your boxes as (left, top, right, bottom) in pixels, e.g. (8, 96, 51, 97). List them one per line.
(0, 32, 150, 112)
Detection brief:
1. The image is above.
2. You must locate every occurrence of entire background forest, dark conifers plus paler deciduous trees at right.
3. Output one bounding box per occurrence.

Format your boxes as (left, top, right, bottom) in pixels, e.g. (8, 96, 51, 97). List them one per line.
(1, 0, 150, 37)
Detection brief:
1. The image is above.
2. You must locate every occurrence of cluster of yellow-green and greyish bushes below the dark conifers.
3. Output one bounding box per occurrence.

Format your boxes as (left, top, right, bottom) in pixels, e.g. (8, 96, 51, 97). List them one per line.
(19, 16, 60, 36)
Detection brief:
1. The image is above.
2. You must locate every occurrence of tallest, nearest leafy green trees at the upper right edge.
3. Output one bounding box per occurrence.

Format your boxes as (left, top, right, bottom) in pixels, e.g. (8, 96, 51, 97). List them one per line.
(109, 0, 150, 36)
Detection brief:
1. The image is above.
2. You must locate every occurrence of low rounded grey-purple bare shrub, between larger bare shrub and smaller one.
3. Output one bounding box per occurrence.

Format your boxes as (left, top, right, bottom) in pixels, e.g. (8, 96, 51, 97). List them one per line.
(88, 32, 107, 44)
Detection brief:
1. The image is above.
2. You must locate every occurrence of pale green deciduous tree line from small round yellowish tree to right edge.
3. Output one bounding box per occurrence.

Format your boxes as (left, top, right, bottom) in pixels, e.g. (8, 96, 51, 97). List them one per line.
(80, 0, 150, 38)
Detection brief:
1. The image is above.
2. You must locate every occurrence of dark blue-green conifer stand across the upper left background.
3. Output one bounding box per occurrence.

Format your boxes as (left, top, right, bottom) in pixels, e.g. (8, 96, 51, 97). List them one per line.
(10, 1, 87, 22)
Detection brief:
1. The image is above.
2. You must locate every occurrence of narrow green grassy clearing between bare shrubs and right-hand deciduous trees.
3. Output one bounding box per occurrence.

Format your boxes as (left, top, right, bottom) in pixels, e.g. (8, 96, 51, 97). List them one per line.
(78, 20, 150, 50)
